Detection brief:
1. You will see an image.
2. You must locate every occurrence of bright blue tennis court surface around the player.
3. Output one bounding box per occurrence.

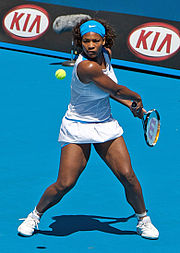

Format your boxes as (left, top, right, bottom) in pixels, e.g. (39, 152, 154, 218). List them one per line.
(0, 0, 180, 253)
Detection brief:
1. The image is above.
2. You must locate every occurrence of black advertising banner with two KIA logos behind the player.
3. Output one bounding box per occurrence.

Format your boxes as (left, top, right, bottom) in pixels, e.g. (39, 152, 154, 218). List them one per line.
(0, 0, 180, 77)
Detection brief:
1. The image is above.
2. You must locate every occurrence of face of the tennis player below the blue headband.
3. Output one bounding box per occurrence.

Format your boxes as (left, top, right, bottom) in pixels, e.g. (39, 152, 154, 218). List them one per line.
(82, 32, 105, 58)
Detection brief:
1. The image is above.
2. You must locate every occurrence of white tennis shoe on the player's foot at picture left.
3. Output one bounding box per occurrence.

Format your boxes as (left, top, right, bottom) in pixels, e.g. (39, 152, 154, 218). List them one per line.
(18, 213, 40, 236)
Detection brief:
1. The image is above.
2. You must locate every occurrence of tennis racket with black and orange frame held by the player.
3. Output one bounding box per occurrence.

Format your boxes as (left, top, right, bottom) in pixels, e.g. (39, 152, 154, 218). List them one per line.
(132, 102, 160, 147)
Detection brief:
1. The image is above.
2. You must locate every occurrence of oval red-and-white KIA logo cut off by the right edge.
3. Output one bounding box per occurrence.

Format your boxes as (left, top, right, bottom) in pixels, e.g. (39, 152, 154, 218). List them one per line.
(128, 22, 180, 61)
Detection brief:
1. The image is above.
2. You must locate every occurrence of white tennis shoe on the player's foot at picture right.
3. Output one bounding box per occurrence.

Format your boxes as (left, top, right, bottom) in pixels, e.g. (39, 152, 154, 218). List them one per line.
(136, 216, 159, 239)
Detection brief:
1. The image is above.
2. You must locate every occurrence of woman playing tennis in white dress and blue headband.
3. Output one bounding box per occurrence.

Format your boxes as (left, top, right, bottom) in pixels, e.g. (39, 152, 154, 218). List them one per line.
(18, 19, 159, 239)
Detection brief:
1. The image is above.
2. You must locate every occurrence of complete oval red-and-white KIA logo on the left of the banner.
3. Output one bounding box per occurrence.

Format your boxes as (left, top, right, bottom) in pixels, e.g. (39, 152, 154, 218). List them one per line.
(3, 5, 49, 41)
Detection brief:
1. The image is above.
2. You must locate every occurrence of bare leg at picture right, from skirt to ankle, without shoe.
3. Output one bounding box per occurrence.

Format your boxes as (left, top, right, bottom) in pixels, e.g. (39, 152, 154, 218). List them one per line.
(94, 136, 146, 214)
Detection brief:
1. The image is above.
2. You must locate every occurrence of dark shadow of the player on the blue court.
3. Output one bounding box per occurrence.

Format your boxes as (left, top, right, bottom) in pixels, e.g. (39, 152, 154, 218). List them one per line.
(36, 215, 137, 236)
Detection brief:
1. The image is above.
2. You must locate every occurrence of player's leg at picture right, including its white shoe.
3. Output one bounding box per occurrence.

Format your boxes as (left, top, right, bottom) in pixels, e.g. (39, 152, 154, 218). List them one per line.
(94, 136, 159, 239)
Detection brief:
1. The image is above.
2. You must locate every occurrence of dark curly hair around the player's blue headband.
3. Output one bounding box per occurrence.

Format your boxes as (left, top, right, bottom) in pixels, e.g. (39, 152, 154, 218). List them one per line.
(72, 18, 116, 49)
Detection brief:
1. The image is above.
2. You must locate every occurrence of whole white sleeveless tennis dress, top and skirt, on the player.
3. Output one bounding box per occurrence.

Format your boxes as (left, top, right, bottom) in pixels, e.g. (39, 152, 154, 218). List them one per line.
(58, 50, 123, 147)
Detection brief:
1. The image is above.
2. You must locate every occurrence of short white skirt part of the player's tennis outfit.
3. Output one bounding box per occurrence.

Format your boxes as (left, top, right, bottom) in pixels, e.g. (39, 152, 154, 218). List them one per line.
(58, 117, 123, 147)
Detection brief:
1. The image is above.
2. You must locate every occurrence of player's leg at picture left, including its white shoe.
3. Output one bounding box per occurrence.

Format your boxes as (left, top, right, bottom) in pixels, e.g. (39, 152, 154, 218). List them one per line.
(18, 144, 91, 236)
